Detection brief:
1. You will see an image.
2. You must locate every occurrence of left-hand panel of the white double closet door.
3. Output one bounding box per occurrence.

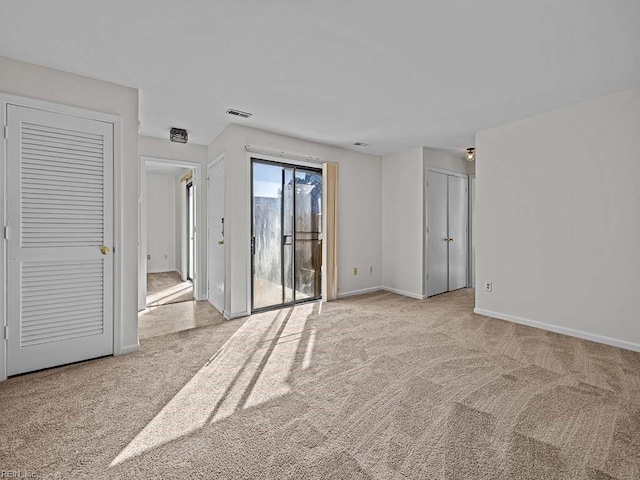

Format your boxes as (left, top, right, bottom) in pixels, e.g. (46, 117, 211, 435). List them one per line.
(427, 171, 449, 297)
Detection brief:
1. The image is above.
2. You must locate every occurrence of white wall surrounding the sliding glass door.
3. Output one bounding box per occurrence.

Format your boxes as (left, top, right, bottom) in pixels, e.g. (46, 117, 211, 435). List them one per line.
(208, 125, 381, 316)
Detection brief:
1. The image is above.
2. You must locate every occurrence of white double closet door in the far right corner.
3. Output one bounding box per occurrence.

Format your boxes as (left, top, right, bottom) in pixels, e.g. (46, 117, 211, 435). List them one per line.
(427, 171, 468, 297)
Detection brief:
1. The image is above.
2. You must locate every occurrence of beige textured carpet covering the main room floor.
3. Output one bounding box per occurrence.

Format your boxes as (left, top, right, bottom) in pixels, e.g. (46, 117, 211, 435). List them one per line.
(0, 290, 640, 480)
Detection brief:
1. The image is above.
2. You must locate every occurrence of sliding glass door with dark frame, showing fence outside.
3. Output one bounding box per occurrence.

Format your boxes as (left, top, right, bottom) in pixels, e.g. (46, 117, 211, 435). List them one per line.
(251, 159, 322, 311)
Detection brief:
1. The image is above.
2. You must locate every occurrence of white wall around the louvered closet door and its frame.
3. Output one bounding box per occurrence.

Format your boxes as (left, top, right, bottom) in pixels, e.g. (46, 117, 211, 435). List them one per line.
(0, 57, 138, 353)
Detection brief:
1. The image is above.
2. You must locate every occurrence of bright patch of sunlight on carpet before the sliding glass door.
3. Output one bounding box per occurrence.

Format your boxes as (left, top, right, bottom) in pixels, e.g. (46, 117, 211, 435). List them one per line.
(110, 303, 318, 467)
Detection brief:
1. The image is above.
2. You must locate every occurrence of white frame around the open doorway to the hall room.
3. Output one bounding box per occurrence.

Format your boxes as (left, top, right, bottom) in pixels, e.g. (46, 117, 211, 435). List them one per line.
(138, 155, 205, 311)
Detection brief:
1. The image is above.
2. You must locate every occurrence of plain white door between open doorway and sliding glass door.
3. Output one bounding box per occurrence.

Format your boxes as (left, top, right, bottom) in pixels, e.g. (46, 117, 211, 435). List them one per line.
(207, 158, 225, 313)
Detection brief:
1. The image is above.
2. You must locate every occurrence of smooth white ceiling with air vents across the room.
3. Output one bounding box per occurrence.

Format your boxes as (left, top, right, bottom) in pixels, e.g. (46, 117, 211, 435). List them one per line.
(0, 0, 640, 153)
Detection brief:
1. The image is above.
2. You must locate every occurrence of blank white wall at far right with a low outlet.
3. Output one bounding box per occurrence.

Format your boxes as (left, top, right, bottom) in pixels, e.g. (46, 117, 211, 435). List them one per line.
(476, 89, 640, 350)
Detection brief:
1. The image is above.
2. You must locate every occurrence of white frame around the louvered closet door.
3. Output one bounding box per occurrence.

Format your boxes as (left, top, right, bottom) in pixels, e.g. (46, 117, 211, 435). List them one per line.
(0, 92, 124, 381)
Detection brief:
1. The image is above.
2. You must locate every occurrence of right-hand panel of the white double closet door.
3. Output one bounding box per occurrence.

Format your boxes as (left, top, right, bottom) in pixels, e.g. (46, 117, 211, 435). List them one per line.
(447, 175, 468, 291)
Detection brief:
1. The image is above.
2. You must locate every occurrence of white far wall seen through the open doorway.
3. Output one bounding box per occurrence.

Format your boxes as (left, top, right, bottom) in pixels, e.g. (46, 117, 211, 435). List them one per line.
(146, 173, 178, 273)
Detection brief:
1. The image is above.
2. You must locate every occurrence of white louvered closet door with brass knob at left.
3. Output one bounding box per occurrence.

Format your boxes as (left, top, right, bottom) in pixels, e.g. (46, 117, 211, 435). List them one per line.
(7, 105, 113, 375)
